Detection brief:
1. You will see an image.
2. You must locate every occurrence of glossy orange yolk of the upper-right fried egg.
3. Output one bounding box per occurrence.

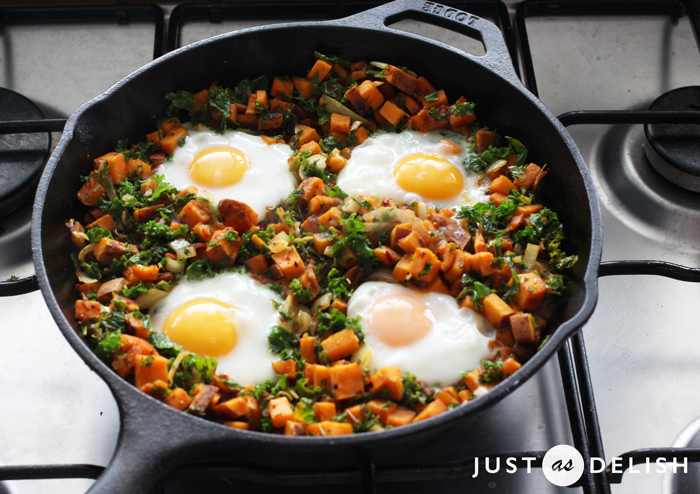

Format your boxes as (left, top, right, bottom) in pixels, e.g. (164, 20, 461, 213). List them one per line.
(394, 153, 464, 199)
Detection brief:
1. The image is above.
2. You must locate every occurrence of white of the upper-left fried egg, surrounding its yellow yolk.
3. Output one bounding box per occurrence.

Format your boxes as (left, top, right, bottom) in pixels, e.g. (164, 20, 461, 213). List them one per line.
(158, 131, 297, 221)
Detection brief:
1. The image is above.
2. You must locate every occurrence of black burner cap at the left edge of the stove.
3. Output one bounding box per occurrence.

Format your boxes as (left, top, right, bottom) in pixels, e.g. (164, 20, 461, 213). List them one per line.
(0, 88, 51, 216)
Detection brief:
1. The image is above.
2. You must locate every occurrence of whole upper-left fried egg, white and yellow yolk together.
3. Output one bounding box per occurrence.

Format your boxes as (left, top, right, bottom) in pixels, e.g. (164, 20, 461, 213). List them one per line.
(159, 131, 297, 221)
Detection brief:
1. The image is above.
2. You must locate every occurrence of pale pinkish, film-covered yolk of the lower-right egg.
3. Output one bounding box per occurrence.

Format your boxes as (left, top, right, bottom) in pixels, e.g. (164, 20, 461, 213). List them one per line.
(365, 295, 435, 347)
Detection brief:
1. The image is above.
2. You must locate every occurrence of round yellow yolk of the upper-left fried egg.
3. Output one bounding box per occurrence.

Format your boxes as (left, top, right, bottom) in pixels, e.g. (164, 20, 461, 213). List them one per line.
(190, 147, 250, 187)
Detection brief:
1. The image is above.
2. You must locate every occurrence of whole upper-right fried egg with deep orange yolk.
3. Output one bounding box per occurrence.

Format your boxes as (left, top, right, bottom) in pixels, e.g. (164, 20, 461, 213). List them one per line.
(338, 130, 488, 208)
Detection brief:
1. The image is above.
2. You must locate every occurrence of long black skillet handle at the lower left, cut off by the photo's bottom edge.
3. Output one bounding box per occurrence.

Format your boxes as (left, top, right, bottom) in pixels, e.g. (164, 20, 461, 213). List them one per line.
(88, 386, 222, 494)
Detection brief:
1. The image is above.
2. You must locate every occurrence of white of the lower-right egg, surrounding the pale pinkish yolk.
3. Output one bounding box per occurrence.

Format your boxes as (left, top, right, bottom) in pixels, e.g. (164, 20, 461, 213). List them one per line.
(347, 281, 495, 386)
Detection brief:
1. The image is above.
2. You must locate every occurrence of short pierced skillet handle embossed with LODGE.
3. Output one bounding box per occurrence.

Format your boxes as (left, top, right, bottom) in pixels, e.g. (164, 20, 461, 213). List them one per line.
(338, 0, 520, 84)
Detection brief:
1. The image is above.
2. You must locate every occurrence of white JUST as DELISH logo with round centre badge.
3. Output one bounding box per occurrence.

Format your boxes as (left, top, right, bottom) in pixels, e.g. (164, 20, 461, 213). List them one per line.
(472, 444, 688, 487)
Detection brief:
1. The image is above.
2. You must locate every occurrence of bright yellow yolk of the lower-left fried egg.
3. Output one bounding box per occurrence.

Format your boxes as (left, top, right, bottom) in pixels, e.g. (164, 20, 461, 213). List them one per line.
(163, 299, 236, 357)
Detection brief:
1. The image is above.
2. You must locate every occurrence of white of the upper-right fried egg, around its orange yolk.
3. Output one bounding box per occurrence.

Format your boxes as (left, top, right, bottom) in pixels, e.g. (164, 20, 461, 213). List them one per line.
(338, 130, 488, 208)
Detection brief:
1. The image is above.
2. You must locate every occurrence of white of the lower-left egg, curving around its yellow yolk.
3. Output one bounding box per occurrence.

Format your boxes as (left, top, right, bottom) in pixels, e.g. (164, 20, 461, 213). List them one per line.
(151, 273, 283, 386)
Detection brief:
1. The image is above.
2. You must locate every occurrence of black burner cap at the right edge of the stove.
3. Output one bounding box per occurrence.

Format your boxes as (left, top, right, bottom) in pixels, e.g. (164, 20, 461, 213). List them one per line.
(644, 86, 700, 192)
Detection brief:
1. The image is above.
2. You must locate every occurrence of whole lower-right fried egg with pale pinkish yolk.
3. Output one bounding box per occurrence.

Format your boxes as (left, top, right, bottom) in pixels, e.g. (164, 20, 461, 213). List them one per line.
(347, 281, 494, 386)
